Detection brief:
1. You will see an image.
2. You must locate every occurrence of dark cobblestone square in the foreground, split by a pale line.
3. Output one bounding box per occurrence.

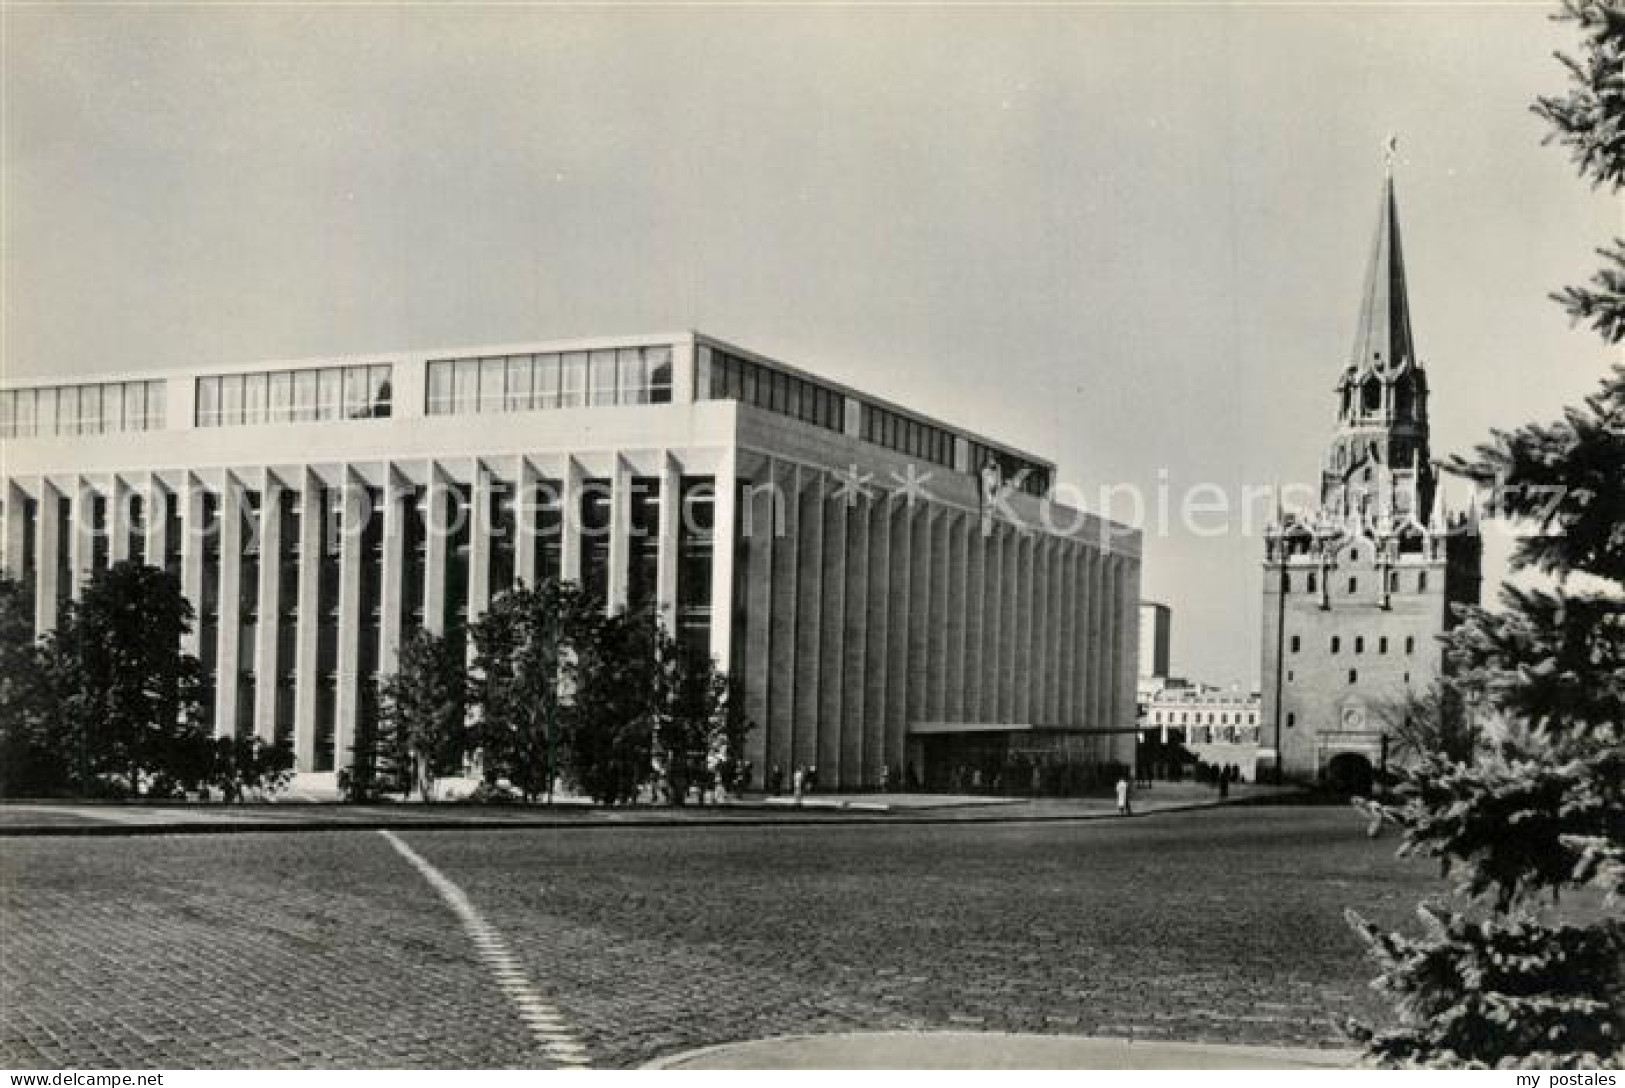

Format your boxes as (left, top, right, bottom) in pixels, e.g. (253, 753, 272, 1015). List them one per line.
(0, 807, 1440, 1067)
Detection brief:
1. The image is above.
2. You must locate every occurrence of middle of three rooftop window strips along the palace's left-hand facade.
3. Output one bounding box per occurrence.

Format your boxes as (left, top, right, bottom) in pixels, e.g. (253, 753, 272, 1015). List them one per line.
(195, 362, 393, 427)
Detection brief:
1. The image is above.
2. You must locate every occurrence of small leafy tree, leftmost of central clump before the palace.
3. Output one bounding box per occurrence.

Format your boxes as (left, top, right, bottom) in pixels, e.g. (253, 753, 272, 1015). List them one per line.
(379, 630, 468, 801)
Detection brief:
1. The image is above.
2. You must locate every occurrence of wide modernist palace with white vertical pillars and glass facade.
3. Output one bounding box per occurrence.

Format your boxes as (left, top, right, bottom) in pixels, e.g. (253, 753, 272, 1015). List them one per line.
(0, 333, 1141, 786)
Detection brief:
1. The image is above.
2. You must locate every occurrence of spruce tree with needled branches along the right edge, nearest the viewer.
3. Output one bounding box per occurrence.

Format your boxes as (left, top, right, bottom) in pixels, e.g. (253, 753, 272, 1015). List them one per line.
(1352, 0, 1625, 1069)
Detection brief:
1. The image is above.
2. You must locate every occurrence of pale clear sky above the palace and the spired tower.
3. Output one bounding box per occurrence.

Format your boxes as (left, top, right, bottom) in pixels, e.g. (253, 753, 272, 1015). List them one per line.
(0, 3, 1622, 689)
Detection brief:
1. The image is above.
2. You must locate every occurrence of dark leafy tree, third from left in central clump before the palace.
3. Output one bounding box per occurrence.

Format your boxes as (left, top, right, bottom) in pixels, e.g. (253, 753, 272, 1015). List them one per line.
(562, 609, 660, 804)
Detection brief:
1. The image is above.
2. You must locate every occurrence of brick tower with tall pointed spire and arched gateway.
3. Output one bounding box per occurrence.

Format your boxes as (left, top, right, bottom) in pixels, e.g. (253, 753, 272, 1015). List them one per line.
(1263, 164, 1480, 784)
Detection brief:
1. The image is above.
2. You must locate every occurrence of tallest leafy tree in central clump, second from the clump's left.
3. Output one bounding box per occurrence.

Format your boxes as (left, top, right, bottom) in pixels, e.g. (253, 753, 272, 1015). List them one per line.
(470, 581, 603, 801)
